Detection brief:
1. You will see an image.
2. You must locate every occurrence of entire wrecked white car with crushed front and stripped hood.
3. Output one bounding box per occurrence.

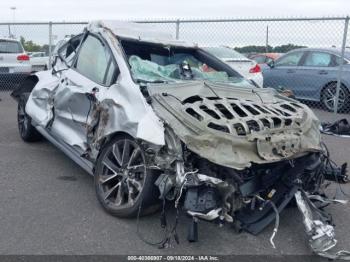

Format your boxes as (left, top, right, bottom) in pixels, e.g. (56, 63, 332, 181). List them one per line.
(12, 21, 345, 258)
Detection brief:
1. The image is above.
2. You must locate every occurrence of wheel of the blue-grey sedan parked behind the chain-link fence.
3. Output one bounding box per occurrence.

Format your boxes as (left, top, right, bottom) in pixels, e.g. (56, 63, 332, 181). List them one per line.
(321, 82, 350, 112)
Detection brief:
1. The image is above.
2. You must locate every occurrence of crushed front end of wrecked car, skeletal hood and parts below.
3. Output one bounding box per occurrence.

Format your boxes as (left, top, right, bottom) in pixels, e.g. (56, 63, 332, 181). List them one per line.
(139, 82, 348, 256)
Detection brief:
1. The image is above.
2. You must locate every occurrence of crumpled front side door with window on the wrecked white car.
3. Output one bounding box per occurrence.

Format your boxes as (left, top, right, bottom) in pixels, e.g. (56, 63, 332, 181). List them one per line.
(51, 34, 117, 154)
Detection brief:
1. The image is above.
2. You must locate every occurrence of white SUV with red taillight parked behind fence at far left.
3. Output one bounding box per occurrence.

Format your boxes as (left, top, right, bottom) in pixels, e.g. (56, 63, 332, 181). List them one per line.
(0, 38, 32, 86)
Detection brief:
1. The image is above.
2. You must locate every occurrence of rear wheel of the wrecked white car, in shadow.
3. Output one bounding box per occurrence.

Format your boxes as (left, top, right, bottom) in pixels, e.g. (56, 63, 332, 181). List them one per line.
(17, 93, 42, 142)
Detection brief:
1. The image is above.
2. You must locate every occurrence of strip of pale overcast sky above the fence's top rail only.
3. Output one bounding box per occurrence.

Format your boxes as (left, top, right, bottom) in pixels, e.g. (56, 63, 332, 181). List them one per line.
(0, 0, 350, 22)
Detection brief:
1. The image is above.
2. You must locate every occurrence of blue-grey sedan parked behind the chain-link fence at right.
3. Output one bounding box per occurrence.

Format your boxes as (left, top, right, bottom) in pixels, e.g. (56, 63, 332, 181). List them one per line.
(263, 48, 350, 111)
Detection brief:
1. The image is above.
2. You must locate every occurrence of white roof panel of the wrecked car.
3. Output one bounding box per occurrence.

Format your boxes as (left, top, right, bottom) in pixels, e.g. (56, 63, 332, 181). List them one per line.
(88, 20, 197, 47)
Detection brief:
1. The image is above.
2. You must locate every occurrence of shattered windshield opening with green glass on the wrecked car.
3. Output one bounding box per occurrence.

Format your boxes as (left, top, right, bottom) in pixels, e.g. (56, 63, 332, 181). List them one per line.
(121, 41, 251, 87)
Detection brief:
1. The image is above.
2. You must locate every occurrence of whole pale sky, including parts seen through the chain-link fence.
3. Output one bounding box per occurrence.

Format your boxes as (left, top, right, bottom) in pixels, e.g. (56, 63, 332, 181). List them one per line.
(0, 0, 350, 47)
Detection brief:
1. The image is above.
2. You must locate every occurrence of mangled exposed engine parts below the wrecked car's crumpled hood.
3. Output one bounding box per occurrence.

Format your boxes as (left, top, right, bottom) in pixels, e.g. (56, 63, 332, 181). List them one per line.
(142, 124, 347, 258)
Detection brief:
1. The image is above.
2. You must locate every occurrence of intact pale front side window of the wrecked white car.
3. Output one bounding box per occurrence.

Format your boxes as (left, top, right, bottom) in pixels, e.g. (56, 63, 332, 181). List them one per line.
(75, 35, 116, 85)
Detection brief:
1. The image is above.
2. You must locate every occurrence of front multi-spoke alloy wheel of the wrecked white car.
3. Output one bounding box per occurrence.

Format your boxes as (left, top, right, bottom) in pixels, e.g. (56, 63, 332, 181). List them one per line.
(94, 136, 159, 217)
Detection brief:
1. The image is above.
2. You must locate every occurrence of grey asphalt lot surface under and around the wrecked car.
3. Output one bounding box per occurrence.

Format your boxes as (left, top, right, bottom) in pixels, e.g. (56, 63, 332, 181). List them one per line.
(0, 92, 350, 255)
